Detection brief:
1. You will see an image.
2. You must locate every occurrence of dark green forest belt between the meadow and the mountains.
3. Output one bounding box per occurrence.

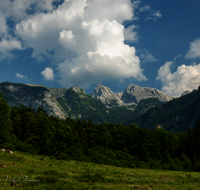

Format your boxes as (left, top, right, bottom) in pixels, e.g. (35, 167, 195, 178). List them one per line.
(0, 93, 200, 172)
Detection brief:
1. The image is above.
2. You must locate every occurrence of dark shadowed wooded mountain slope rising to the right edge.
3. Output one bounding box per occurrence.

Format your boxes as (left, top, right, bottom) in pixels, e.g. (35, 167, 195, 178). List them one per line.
(135, 88, 200, 132)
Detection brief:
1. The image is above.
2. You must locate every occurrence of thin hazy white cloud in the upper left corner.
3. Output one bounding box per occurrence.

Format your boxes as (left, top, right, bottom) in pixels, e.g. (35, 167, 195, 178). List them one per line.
(0, 0, 53, 60)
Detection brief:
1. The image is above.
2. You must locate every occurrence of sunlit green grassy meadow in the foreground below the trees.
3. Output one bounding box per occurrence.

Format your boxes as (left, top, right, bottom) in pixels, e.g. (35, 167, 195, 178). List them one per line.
(0, 151, 200, 190)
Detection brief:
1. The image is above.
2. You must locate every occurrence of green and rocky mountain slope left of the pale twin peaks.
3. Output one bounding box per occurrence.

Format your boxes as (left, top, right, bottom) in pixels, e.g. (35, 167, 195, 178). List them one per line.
(0, 82, 133, 123)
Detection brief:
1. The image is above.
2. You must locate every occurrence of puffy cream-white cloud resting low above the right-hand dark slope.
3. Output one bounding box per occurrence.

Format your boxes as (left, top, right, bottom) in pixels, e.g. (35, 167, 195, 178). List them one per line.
(156, 61, 200, 97)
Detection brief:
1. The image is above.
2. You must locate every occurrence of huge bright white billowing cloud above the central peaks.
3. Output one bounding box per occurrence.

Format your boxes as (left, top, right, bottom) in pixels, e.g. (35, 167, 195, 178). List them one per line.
(15, 0, 147, 88)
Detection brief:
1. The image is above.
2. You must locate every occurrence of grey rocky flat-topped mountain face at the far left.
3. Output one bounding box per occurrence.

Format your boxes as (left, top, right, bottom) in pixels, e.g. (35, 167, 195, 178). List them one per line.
(0, 82, 66, 118)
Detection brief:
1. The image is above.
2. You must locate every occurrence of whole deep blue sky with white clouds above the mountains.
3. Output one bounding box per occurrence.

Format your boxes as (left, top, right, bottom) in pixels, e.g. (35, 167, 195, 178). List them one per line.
(0, 0, 200, 97)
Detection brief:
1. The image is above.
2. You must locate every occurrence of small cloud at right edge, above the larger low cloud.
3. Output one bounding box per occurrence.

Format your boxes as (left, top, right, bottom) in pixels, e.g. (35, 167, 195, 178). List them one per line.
(185, 39, 200, 59)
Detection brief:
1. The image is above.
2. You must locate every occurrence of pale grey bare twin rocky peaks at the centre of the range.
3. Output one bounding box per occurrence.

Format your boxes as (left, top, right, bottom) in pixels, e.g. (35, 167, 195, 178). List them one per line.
(91, 84, 173, 107)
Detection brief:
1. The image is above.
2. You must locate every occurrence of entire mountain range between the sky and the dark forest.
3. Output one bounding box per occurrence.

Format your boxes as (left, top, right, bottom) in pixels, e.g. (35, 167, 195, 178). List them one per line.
(0, 82, 200, 131)
